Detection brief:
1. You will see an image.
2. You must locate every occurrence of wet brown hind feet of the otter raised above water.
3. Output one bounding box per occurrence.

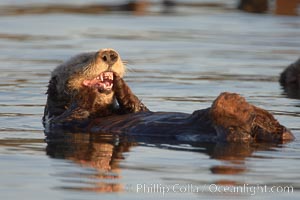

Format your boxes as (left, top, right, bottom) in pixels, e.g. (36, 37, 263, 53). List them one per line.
(210, 93, 293, 141)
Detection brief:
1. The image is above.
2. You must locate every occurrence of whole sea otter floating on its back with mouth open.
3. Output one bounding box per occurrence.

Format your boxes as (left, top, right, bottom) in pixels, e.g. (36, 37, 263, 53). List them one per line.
(43, 49, 294, 142)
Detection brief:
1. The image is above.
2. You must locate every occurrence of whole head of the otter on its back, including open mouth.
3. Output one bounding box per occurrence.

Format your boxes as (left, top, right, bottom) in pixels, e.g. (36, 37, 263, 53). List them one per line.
(47, 49, 125, 115)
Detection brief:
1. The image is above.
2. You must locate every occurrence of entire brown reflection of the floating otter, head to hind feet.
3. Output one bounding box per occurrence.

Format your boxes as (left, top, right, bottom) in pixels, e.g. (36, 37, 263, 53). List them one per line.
(46, 133, 276, 192)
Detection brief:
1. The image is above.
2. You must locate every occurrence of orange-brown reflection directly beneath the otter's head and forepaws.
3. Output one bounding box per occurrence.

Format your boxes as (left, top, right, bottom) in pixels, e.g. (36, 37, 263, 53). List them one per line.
(46, 133, 134, 192)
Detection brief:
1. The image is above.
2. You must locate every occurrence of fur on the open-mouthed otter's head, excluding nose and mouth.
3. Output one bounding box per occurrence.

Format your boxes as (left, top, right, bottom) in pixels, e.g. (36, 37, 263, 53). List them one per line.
(47, 49, 125, 118)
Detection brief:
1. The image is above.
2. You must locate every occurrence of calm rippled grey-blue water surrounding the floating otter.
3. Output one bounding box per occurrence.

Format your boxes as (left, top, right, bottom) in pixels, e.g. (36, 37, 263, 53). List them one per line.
(0, 1, 300, 199)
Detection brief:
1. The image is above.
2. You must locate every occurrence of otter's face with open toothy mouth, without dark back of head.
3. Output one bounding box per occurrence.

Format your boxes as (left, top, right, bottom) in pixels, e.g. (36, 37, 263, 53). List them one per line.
(66, 49, 125, 94)
